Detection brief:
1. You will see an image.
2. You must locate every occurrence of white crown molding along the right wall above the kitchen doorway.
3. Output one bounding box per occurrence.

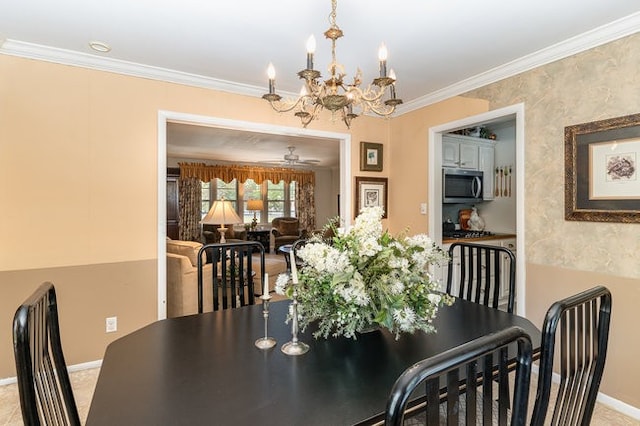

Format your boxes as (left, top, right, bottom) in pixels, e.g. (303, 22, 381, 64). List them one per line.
(397, 12, 640, 115)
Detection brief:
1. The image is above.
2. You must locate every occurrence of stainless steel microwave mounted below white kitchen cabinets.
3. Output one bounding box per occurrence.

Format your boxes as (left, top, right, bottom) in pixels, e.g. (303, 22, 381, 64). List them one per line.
(442, 167, 484, 203)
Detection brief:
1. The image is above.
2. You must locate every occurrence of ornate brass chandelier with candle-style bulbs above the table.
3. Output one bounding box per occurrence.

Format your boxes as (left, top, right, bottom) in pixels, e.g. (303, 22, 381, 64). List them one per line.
(262, 0, 402, 128)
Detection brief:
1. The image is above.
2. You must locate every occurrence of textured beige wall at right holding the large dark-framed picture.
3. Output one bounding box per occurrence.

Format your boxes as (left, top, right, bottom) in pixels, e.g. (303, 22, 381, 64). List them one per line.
(467, 34, 640, 407)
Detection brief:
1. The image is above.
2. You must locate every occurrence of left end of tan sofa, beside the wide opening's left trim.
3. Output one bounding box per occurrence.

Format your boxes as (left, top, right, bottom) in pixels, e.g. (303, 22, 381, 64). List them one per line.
(167, 240, 213, 318)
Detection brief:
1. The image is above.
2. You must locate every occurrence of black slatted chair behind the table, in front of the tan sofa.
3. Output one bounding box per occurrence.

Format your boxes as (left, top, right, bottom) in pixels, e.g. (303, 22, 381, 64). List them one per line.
(198, 241, 265, 313)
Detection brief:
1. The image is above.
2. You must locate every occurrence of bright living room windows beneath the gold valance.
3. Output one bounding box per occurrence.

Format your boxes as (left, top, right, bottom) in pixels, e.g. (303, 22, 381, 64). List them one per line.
(200, 179, 296, 223)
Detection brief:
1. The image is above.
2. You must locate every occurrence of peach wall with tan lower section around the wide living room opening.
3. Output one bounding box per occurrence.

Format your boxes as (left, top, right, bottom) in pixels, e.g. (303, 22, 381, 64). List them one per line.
(0, 55, 389, 379)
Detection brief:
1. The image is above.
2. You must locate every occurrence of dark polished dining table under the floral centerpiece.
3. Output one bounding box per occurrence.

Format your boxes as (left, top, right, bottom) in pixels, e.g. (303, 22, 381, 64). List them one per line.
(86, 299, 540, 426)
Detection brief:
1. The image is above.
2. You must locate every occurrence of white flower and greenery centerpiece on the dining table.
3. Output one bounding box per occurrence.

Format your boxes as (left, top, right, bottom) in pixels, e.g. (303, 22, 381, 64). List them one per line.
(276, 207, 452, 338)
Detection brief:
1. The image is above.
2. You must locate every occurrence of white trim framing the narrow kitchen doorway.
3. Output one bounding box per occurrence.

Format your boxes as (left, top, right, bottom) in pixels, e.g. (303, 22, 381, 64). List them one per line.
(427, 103, 526, 316)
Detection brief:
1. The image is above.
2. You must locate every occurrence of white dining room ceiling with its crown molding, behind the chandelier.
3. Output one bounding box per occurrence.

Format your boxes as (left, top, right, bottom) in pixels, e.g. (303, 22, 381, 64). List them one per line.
(0, 0, 640, 167)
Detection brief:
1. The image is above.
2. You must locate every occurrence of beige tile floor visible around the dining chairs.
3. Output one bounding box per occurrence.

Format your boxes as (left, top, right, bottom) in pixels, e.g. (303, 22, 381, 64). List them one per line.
(0, 368, 640, 426)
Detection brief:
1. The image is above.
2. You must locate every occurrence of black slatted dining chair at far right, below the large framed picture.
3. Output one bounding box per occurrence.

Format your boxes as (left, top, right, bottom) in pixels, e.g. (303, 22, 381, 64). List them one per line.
(531, 286, 612, 426)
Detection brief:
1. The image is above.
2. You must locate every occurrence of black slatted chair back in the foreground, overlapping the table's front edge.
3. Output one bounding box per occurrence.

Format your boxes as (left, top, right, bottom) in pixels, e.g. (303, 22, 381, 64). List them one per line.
(385, 326, 532, 426)
